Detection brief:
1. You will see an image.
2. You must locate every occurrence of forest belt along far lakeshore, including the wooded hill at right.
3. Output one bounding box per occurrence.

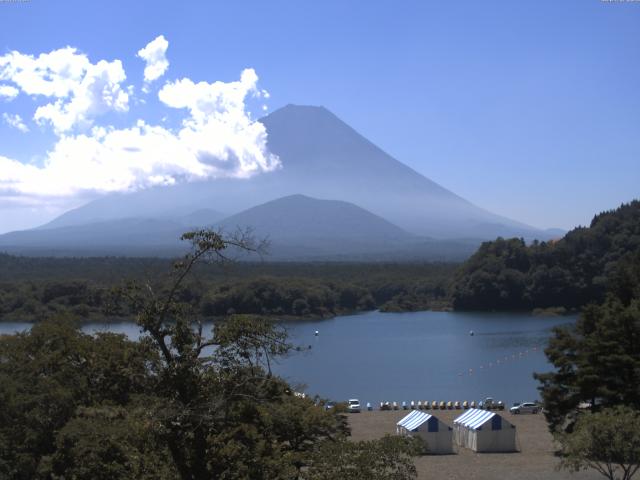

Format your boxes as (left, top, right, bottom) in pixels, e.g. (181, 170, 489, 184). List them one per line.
(0, 201, 640, 321)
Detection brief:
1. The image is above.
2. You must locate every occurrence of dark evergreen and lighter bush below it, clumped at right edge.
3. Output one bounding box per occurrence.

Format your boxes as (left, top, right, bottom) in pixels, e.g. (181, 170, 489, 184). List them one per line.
(535, 248, 640, 480)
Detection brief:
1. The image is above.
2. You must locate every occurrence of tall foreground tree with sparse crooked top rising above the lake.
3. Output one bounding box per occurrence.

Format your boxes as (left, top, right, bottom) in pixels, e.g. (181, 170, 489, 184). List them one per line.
(120, 230, 346, 480)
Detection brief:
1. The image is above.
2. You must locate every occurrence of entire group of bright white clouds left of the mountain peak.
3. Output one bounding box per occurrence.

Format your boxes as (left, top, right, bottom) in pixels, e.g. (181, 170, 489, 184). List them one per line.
(0, 36, 280, 205)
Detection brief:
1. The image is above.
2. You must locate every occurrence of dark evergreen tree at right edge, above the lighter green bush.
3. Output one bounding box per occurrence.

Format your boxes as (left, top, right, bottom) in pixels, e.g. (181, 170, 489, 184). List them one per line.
(536, 254, 640, 431)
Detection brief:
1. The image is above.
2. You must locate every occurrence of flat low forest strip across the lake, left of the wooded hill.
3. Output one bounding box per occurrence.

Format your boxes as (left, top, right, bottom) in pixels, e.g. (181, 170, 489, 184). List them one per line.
(0, 255, 456, 321)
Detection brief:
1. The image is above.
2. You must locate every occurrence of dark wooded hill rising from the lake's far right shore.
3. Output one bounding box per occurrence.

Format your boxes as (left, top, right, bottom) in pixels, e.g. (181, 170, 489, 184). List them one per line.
(451, 201, 640, 310)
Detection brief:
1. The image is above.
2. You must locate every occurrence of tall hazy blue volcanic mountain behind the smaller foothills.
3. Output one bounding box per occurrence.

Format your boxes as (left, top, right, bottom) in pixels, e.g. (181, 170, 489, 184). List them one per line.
(0, 105, 558, 256)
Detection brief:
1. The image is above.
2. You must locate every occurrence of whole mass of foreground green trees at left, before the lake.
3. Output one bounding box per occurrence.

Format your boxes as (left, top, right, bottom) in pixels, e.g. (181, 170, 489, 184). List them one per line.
(0, 230, 415, 480)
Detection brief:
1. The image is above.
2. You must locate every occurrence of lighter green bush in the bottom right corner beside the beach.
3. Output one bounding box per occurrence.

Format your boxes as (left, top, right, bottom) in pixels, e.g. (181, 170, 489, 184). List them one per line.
(556, 407, 640, 480)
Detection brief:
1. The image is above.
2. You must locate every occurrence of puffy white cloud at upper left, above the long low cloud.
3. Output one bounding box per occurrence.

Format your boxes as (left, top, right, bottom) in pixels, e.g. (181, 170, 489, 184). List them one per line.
(0, 47, 129, 134)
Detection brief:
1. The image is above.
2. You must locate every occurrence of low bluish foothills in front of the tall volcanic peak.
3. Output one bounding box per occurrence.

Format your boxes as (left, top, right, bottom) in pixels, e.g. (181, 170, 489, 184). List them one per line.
(0, 195, 477, 261)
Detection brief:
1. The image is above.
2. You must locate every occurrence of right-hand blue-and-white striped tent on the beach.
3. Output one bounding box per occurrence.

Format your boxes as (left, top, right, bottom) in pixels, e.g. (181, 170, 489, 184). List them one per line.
(453, 408, 517, 452)
